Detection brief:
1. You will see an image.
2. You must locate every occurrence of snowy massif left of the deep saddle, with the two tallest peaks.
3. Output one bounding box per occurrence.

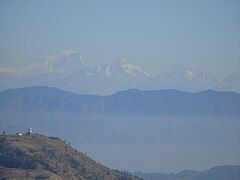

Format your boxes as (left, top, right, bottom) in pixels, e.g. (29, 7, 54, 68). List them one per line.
(0, 50, 150, 94)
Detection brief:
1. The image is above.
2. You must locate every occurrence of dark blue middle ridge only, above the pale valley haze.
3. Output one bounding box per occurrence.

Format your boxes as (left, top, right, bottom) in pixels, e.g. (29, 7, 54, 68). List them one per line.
(0, 86, 240, 118)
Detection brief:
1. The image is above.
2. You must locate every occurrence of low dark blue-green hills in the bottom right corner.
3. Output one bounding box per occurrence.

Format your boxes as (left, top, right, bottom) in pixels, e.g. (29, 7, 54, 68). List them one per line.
(135, 166, 240, 180)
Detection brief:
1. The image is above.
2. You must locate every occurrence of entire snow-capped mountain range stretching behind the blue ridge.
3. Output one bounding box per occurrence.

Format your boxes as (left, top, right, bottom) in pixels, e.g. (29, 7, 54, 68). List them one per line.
(0, 50, 240, 95)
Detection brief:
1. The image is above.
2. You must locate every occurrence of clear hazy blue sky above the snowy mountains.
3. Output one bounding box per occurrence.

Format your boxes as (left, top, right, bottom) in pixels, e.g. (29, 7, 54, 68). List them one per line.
(0, 0, 240, 76)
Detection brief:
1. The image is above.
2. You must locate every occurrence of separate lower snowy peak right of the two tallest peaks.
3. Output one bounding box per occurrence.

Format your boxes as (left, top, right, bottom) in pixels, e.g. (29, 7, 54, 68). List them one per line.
(143, 64, 230, 92)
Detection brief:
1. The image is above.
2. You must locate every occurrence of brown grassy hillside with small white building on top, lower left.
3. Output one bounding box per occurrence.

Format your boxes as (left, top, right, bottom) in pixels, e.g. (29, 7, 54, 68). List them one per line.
(0, 134, 141, 179)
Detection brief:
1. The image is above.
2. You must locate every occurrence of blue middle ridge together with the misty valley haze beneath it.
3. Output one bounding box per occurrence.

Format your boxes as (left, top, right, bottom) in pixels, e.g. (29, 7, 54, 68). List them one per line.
(0, 86, 240, 171)
